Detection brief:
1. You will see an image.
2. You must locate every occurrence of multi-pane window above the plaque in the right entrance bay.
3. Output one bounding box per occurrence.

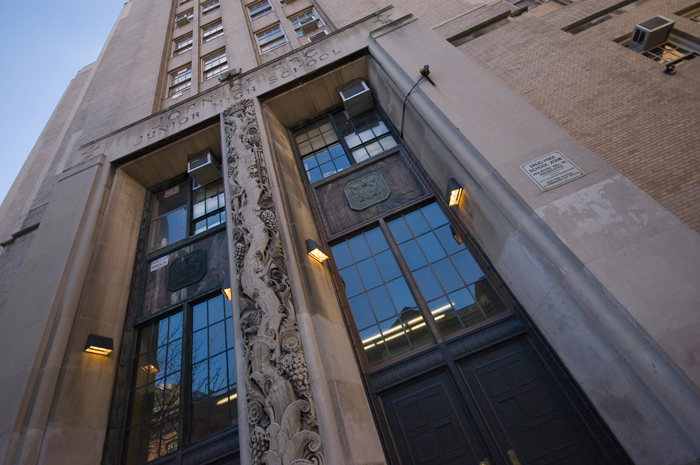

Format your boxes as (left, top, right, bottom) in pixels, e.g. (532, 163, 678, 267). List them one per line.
(294, 110, 397, 183)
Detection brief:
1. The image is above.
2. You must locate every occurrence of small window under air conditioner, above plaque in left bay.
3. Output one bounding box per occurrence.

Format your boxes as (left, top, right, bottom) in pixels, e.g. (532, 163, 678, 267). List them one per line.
(148, 179, 226, 252)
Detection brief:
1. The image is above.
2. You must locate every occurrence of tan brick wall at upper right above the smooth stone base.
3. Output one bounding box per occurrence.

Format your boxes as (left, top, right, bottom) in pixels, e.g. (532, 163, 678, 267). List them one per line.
(459, 0, 700, 232)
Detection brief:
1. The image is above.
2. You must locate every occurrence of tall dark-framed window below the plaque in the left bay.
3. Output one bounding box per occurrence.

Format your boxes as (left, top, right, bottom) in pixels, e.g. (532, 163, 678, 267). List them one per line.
(124, 294, 238, 465)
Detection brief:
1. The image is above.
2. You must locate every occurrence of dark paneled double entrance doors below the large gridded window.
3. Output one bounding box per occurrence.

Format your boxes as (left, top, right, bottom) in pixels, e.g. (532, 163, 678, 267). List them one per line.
(371, 316, 628, 465)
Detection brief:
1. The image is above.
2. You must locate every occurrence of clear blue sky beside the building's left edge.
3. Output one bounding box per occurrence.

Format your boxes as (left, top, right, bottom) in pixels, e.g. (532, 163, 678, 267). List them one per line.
(0, 0, 124, 207)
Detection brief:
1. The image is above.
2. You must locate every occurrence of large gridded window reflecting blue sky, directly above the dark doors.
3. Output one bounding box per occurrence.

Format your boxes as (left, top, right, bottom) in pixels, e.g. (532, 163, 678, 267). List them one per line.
(331, 203, 507, 367)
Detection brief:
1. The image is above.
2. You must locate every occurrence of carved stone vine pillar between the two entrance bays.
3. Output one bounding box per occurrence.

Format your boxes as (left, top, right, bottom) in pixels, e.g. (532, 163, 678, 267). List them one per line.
(223, 100, 325, 465)
